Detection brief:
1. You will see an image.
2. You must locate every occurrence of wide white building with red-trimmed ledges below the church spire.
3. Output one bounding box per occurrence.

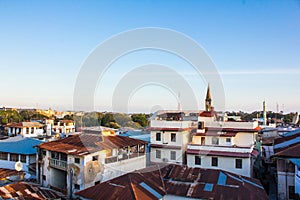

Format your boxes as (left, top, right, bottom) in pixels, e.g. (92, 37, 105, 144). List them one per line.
(186, 119, 258, 177)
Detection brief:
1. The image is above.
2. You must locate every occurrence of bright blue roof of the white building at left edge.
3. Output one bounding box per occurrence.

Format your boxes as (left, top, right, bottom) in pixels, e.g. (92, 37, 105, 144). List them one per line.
(0, 138, 43, 155)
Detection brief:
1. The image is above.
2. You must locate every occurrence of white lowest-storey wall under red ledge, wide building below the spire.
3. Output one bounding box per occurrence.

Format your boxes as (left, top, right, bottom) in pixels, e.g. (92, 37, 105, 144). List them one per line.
(187, 154, 252, 177)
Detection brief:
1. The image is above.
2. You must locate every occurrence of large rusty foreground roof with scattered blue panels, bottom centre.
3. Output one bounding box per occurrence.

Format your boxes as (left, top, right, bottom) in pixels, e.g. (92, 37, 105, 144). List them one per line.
(76, 164, 268, 200)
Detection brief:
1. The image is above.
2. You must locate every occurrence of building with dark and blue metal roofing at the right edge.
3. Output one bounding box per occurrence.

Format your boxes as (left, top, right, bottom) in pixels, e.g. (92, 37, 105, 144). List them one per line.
(274, 129, 300, 200)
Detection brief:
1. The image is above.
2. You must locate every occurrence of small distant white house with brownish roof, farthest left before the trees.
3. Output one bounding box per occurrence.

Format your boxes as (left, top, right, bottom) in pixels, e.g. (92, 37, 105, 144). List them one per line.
(5, 122, 45, 137)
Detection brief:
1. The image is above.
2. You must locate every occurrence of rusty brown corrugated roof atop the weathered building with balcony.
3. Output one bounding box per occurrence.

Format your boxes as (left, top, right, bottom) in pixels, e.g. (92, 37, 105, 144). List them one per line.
(38, 134, 147, 155)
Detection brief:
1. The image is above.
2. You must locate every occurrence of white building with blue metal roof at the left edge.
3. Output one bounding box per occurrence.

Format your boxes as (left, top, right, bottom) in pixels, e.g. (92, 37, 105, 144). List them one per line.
(0, 136, 42, 175)
